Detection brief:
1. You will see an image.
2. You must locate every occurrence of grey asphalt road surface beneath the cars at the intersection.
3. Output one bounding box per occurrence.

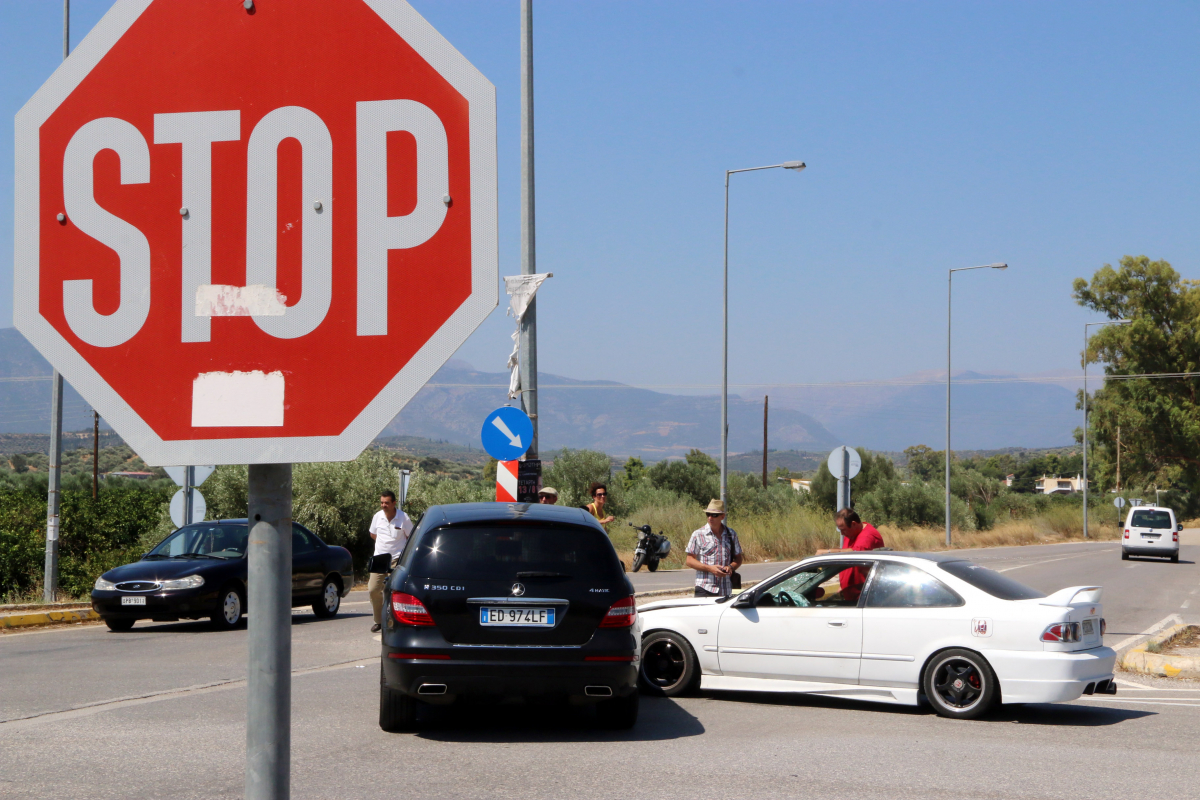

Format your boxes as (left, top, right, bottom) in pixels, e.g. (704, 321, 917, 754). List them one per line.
(0, 534, 1200, 800)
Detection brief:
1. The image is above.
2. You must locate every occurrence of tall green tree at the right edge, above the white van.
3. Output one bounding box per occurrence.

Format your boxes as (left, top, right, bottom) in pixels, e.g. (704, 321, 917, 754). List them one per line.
(1074, 255, 1200, 491)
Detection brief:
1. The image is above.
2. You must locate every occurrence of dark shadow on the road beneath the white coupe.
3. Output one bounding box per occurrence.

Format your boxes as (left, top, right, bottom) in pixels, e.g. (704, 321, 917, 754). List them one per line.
(709, 692, 1157, 727)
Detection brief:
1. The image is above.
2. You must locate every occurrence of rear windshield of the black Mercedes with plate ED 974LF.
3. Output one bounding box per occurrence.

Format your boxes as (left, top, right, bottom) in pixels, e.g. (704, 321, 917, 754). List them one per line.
(406, 525, 620, 581)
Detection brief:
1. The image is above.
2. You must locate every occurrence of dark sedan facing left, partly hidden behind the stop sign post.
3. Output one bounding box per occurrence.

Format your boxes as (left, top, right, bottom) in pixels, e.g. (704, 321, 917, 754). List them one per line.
(91, 519, 354, 631)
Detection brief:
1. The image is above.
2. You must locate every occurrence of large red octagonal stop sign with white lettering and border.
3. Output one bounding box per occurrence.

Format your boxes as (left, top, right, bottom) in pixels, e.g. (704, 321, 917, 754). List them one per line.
(14, 0, 497, 464)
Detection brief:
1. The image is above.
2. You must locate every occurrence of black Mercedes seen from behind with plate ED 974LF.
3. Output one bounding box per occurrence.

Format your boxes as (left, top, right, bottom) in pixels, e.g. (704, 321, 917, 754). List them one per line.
(379, 503, 641, 730)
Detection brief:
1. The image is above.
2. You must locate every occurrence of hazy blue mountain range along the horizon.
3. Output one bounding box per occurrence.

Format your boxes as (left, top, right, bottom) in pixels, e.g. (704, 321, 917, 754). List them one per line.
(0, 327, 1081, 468)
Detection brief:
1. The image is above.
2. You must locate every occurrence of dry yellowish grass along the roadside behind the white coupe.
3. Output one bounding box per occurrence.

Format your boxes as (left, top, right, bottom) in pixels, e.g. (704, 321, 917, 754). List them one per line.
(608, 504, 1120, 570)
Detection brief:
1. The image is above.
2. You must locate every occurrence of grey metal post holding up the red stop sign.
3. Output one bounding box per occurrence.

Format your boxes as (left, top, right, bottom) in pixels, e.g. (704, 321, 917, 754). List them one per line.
(246, 464, 292, 800)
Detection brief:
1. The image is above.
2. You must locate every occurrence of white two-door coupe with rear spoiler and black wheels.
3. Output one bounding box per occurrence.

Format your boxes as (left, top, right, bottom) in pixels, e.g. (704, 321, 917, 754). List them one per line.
(638, 551, 1116, 720)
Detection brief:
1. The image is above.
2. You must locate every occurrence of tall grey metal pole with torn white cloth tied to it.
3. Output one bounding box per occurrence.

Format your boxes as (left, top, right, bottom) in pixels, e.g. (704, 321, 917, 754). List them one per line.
(518, 0, 538, 459)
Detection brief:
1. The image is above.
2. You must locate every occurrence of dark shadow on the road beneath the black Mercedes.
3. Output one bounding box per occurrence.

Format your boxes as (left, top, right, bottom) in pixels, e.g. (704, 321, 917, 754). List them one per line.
(418, 697, 704, 742)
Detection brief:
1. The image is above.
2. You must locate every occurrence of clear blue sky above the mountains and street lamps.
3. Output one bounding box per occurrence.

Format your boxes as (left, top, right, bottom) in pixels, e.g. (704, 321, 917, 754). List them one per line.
(0, 0, 1200, 393)
